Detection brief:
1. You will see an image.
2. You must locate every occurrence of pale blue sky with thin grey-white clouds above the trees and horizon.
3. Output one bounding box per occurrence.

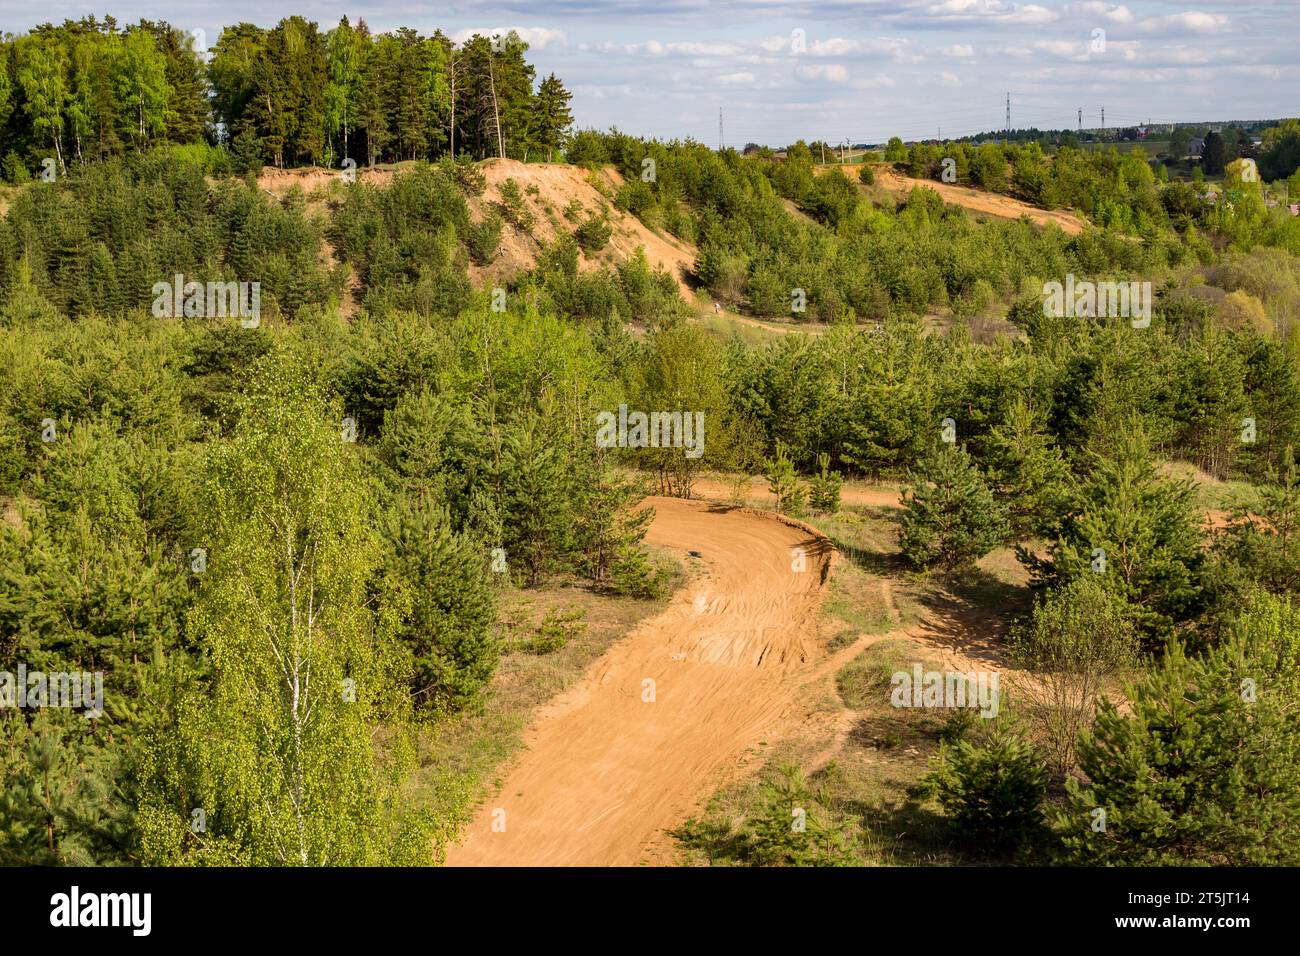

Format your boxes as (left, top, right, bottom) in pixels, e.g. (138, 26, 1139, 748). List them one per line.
(0, 0, 1300, 146)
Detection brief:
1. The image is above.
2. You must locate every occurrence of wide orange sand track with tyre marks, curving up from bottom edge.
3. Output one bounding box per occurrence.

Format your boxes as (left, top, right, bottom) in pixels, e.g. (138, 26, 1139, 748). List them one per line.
(447, 498, 832, 866)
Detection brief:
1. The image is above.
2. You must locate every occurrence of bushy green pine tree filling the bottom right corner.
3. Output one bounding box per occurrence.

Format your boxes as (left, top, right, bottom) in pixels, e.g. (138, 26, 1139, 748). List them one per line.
(1056, 597, 1300, 866)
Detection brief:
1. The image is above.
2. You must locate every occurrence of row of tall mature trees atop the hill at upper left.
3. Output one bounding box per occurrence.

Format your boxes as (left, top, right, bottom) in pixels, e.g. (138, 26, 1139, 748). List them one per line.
(0, 16, 572, 182)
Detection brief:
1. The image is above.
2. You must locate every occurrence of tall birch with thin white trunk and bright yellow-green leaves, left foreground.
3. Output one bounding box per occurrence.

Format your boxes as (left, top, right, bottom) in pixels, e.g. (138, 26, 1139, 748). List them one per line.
(133, 350, 454, 866)
